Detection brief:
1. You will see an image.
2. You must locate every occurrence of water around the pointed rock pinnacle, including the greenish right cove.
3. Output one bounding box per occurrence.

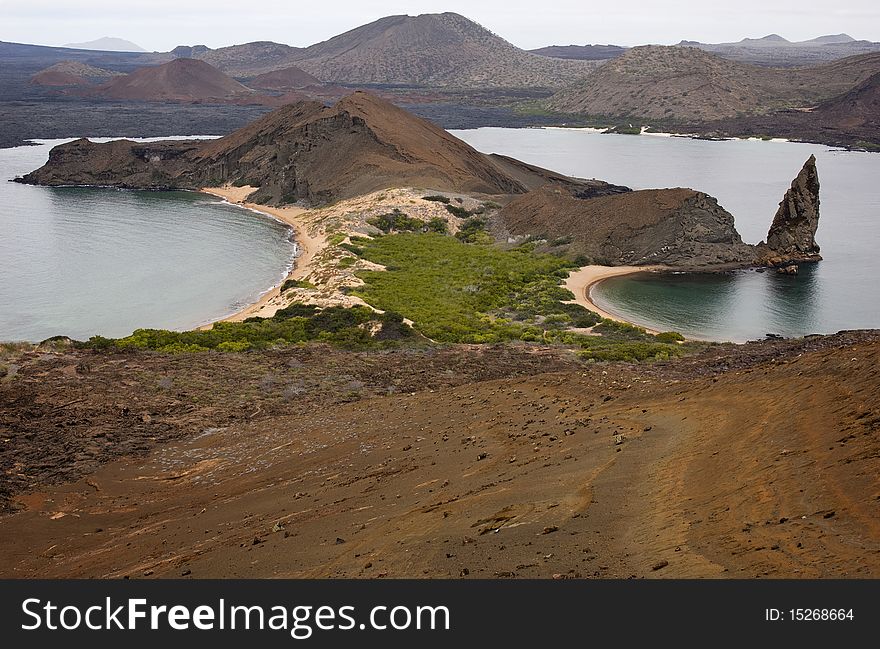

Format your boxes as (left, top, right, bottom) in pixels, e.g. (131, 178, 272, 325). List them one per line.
(455, 128, 880, 342)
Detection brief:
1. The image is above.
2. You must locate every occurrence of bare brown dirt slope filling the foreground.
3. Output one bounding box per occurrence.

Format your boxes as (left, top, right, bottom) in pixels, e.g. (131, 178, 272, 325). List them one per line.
(0, 335, 880, 578)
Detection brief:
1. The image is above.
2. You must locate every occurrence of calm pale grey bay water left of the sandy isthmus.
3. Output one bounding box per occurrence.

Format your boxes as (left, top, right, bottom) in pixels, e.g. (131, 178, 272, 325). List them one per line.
(0, 140, 296, 341)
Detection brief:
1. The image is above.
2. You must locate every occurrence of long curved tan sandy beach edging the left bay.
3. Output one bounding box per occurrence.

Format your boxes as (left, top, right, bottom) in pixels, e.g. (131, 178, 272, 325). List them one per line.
(198, 185, 327, 329)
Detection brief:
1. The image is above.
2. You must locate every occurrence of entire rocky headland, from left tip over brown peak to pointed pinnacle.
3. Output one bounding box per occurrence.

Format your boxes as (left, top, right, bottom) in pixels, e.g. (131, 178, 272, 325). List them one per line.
(19, 92, 819, 268)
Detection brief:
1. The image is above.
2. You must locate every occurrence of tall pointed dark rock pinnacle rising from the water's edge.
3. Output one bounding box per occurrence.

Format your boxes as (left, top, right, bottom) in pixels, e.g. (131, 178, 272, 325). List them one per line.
(760, 155, 821, 266)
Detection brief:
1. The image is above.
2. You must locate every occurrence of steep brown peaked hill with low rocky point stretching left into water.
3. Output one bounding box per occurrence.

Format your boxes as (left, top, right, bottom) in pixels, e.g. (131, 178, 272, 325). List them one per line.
(22, 92, 605, 204)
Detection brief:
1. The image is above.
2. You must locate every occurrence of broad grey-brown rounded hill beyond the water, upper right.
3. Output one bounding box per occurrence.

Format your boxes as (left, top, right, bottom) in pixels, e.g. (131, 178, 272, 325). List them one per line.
(550, 45, 880, 122)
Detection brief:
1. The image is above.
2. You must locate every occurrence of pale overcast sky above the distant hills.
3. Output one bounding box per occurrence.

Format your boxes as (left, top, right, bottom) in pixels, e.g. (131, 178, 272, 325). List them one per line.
(0, 0, 880, 51)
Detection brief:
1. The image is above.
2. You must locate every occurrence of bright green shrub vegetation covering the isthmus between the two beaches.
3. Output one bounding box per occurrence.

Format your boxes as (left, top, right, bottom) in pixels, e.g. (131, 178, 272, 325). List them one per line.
(77, 215, 686, 362)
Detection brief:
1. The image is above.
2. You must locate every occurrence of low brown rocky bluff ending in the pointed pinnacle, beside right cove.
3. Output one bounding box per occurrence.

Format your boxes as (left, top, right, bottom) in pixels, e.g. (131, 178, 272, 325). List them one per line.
(499, 156, 821, 272)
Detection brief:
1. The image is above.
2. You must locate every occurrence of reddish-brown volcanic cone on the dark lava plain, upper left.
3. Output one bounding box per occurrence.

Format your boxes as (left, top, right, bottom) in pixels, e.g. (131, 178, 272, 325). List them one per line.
(96, 59, 253, 102)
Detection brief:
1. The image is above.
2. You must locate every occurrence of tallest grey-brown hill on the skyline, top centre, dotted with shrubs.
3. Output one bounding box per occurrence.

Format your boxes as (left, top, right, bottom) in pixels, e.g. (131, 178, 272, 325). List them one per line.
(288, 13, 595, 88)
